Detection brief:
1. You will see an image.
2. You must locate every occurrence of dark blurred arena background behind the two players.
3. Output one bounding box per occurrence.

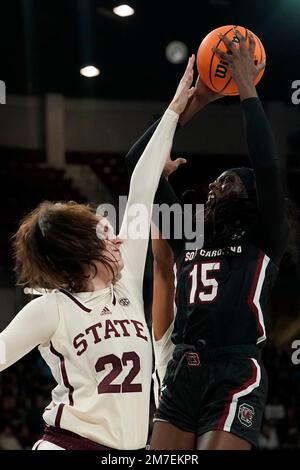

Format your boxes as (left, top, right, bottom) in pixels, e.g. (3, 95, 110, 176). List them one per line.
(0, 0, 300, 449)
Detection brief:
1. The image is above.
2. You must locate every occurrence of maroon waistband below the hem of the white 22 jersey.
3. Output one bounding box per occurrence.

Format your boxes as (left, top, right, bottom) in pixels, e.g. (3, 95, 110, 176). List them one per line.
(42, 426, 113, 450)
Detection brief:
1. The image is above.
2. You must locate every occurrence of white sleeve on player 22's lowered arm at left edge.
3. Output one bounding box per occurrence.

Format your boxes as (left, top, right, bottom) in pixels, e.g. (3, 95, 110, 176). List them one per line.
(0, 294, 59, 371)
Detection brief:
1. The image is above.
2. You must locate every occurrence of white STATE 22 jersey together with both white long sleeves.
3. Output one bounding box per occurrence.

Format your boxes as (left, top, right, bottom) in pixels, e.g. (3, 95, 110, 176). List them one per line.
(0, 109, 179, 450)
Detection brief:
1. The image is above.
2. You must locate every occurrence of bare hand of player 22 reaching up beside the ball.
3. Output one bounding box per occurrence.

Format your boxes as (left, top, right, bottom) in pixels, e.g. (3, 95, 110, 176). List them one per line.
(169, 54, 195, 115)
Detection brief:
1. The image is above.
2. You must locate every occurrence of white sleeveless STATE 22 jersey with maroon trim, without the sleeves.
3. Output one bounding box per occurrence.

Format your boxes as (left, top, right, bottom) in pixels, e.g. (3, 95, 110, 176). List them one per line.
(40, 264, 152, 449)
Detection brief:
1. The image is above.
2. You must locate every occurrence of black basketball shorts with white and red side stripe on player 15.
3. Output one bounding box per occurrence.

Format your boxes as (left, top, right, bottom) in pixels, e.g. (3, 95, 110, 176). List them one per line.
(154, 346, 267, 446)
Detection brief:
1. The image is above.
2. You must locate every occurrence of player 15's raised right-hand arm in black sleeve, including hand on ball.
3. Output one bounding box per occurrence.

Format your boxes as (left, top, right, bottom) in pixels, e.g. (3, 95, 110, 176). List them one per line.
(216, 30, 288, 264)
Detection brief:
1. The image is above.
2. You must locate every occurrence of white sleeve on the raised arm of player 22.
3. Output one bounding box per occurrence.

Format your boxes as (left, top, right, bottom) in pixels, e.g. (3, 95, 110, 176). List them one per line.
(119, 109, 179, 291)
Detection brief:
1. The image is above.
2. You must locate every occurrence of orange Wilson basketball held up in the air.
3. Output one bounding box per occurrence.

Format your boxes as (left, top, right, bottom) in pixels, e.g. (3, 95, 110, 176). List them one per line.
(197, 25, 266, 95)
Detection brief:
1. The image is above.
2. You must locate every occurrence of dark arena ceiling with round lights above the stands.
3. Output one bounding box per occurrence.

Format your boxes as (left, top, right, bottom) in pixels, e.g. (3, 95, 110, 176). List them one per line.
(0, 0, 300, 101)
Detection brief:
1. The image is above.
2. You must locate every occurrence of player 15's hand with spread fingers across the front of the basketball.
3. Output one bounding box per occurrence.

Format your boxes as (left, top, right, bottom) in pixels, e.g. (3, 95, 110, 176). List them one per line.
(213, 29, 266, 94)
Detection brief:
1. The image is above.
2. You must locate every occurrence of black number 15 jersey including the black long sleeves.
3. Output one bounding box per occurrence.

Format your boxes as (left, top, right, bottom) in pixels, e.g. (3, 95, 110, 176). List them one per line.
(126, 98, 289, 345)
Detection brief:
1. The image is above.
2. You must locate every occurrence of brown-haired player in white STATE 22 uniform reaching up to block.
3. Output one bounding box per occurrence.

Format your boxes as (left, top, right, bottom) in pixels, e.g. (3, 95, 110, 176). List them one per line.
(0, 56, 195, 450)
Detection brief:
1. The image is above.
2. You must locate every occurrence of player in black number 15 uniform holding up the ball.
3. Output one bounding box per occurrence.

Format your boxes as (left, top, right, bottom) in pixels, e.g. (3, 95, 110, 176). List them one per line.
(127, 31, 288, 450)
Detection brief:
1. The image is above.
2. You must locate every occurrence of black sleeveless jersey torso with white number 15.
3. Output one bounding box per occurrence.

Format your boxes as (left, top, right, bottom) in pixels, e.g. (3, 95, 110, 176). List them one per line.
(172, 242, 278, 346)
